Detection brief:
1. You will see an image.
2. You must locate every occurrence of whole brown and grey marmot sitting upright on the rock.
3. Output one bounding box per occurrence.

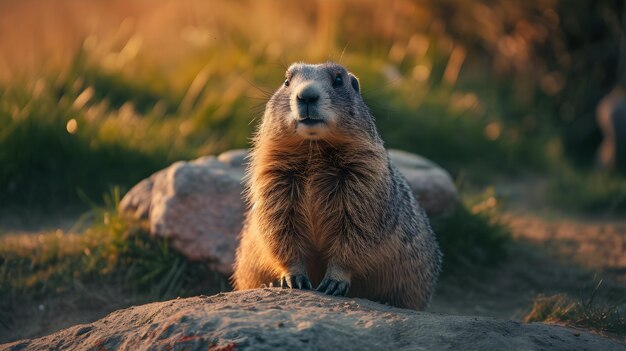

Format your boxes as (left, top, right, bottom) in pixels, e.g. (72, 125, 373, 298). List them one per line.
(232, 62, 441, 309)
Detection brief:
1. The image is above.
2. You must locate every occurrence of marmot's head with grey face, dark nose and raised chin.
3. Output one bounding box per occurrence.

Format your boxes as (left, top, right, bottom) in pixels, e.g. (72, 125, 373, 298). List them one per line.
(264, 62, 377, 140)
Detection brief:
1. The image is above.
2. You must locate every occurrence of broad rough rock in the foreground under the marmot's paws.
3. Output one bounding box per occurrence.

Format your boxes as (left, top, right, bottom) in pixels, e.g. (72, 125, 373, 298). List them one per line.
(0, 288, 626, 351)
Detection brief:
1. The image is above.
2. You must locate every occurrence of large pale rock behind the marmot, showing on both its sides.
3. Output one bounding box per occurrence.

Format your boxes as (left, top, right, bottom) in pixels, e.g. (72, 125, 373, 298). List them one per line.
(120, 150, 457, 274)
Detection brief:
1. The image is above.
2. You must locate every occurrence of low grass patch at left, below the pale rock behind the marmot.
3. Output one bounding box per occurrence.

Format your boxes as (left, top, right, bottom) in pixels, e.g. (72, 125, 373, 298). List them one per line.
(0, 192, 229, 322)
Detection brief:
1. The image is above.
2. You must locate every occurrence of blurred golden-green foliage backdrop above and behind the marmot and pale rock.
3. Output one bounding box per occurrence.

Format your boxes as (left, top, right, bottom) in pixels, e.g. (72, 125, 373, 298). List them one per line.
(0, 0, 624, 206)
